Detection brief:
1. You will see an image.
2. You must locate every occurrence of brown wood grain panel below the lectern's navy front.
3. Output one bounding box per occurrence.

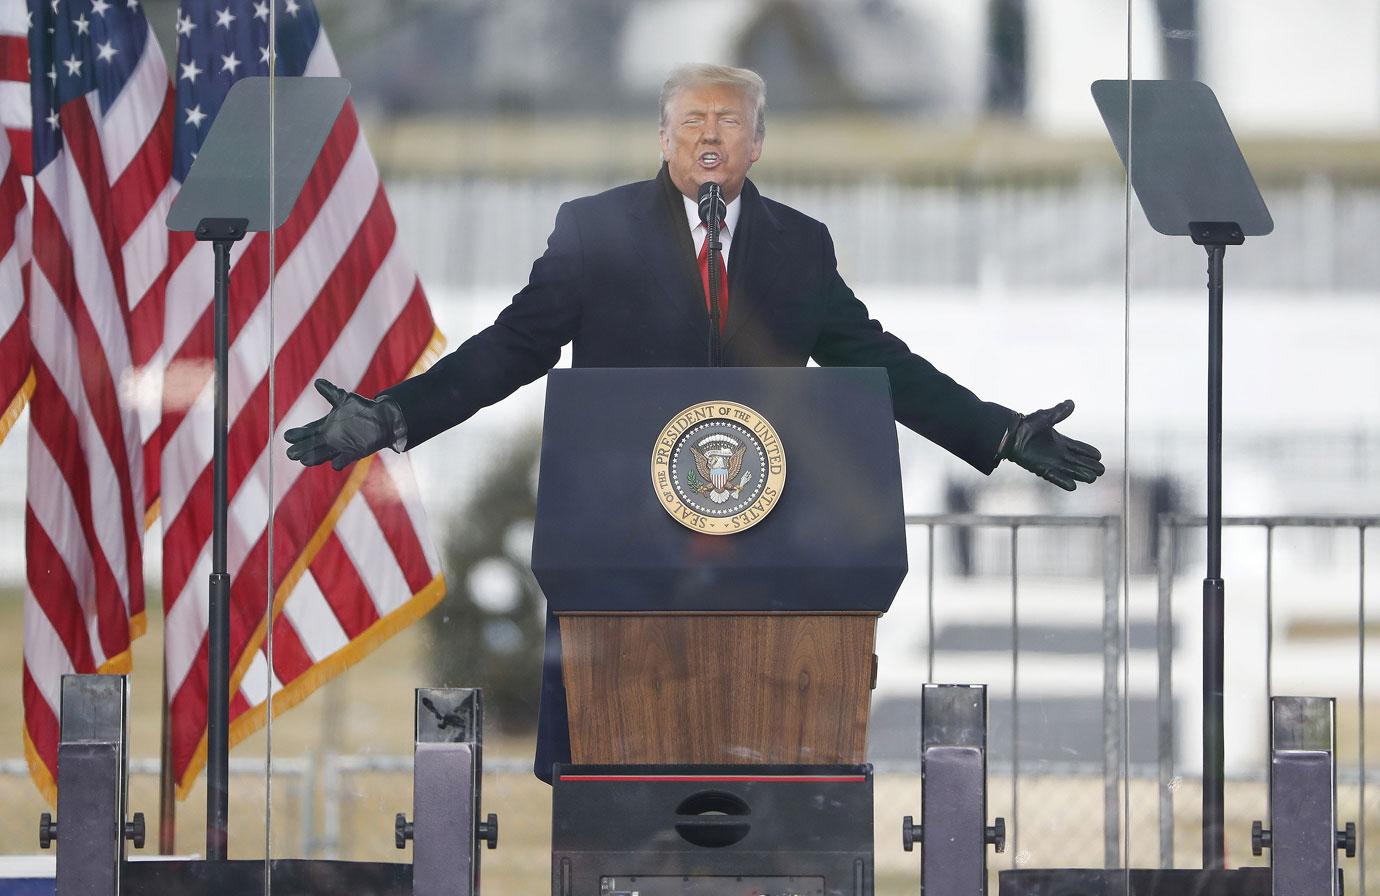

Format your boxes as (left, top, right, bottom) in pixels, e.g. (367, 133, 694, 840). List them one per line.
(560, 613, 876, 763)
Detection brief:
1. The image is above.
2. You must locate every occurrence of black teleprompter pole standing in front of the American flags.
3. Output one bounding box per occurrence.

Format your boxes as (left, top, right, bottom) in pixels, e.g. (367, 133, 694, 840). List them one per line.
(196, 218, 248, 861)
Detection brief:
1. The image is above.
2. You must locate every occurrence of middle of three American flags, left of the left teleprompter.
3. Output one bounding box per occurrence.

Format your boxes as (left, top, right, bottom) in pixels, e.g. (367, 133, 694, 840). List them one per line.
(23, 0, 171, 798)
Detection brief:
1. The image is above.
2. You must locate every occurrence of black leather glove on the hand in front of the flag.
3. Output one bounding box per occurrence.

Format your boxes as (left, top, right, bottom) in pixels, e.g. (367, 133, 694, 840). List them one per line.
(283, 380, 404, 469)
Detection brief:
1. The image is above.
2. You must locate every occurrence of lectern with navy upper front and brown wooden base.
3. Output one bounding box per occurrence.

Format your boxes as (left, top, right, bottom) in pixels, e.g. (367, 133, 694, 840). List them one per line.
(533, 369, 907, 765)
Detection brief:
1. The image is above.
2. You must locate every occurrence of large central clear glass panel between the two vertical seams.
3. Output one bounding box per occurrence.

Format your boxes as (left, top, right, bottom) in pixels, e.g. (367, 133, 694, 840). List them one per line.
(259, 0, 1131, 895)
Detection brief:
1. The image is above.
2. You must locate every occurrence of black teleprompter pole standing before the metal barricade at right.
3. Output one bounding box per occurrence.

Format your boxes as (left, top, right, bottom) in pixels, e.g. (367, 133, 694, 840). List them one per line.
(1188, 222, 1245, 868)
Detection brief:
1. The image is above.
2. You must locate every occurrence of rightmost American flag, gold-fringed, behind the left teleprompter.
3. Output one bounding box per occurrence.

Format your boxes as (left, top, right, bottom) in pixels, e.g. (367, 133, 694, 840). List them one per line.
(161, 0, 444, 795)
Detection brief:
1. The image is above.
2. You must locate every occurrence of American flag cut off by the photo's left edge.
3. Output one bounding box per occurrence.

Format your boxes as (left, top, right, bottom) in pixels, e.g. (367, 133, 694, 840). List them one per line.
(0, 0, 33, 442)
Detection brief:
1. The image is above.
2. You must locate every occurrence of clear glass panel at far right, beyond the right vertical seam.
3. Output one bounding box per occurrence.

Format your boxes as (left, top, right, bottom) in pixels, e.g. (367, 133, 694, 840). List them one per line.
(1129, 0, 1380, 892)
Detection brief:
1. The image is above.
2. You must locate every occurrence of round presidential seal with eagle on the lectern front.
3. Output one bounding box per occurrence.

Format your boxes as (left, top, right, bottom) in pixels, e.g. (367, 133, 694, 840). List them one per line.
(651, 402, 785, 536)
